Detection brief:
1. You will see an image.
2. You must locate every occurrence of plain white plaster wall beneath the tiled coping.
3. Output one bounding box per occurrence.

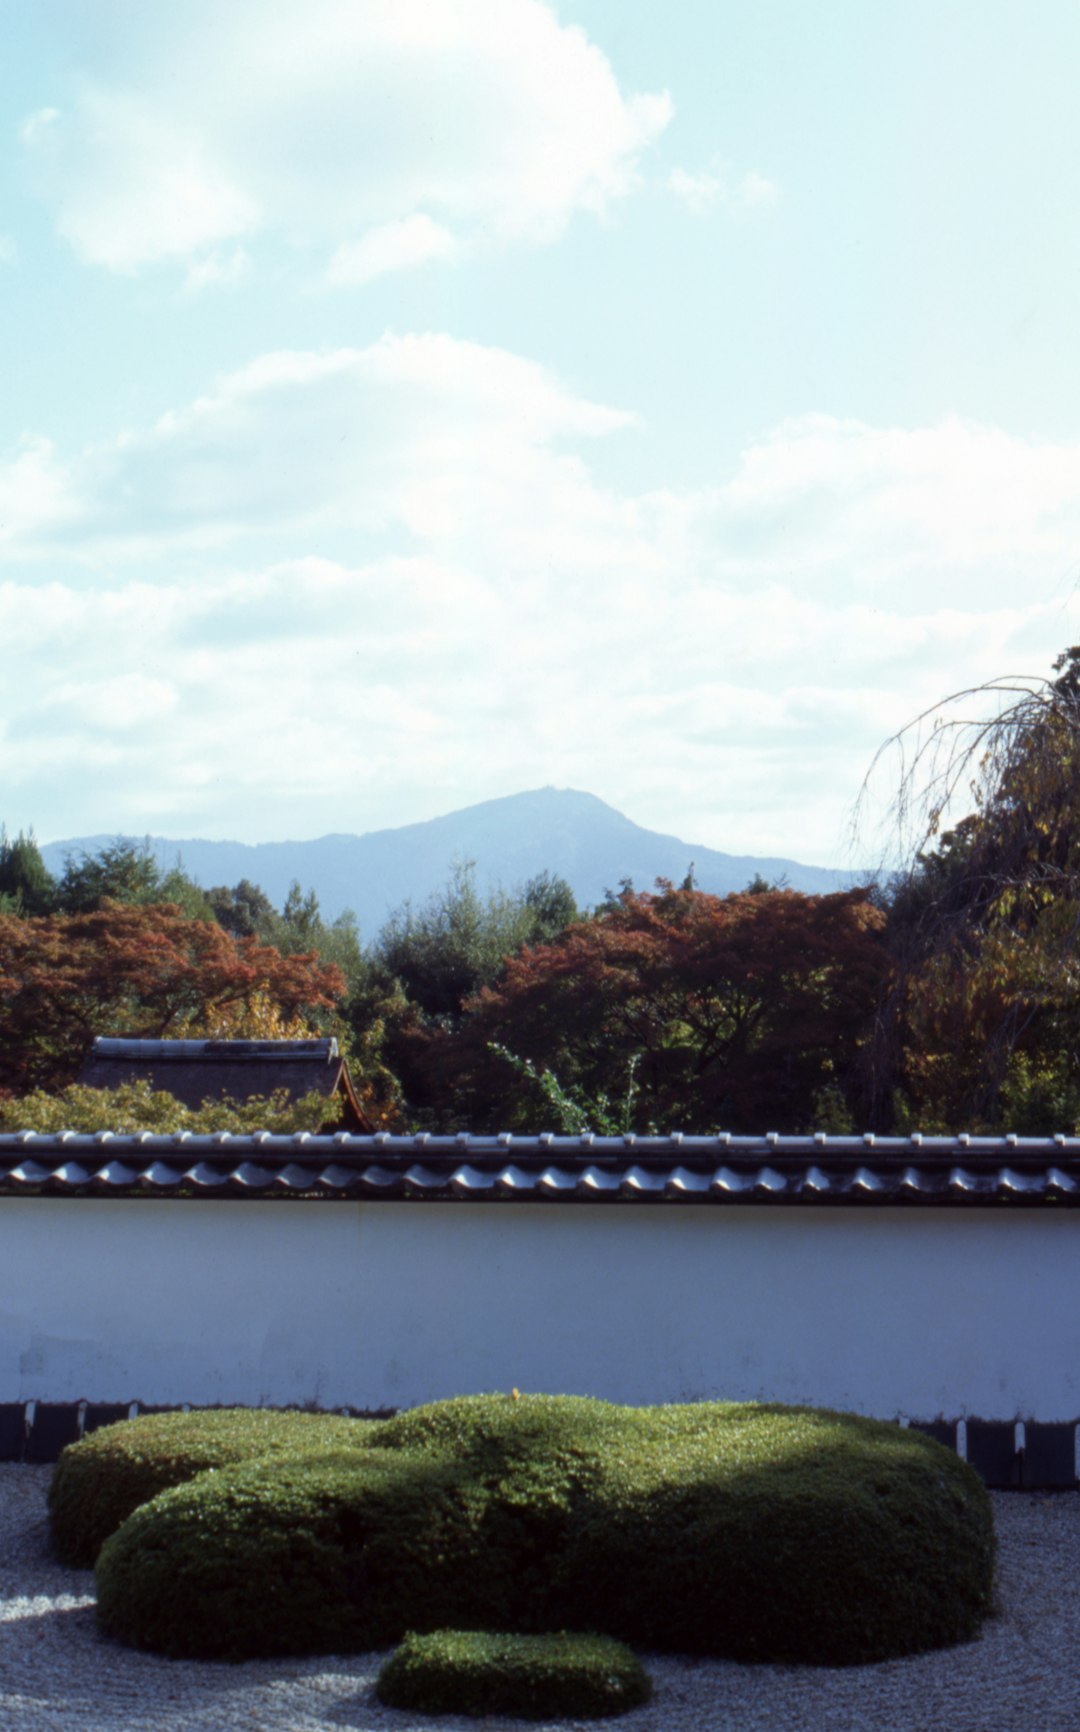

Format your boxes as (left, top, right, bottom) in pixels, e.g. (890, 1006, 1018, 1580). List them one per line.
(8, 1199, 1080, 1420)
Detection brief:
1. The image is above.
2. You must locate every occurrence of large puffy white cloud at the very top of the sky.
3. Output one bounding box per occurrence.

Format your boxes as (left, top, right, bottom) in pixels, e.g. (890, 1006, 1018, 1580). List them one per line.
(23, 0, 672, 275)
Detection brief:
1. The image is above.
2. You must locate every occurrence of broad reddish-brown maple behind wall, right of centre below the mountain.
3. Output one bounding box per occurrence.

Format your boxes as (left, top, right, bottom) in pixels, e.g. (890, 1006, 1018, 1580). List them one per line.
(429, 883, 886, 1131)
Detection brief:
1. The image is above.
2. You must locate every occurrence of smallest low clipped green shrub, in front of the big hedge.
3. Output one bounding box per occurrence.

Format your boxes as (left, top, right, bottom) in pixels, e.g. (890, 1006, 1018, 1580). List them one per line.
(376, 1630, 653, 1720)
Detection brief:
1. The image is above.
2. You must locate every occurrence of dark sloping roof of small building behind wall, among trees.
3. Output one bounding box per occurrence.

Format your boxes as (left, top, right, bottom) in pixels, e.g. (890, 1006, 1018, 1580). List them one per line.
(80, 1036, 374, 1131)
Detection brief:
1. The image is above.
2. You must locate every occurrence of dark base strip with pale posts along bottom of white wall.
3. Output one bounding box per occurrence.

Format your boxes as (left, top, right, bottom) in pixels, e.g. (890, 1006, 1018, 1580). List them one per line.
(0, 1401, 1080, 1491)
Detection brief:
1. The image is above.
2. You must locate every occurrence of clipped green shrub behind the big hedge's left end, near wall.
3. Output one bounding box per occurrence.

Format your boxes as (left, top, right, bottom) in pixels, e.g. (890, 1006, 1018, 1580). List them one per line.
(48, 1408, 377, 1569)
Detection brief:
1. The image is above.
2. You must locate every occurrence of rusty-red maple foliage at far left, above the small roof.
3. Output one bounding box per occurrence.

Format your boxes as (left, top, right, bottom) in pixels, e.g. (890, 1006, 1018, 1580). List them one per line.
(0, 902, 344, 1093)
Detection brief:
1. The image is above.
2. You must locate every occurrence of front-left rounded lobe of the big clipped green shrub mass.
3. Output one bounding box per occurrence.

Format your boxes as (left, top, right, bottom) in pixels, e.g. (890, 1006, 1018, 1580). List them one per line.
(97, 1450, 484, 1659)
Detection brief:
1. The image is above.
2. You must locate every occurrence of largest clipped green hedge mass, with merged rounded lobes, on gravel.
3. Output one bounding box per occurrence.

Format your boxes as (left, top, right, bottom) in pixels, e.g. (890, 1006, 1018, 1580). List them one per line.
(97, 1396, 993, 1664)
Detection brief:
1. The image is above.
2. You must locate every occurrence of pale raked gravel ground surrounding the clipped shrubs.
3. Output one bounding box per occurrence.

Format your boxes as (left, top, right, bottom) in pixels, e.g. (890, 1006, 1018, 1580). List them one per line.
(0, 1464, 1080, 1732)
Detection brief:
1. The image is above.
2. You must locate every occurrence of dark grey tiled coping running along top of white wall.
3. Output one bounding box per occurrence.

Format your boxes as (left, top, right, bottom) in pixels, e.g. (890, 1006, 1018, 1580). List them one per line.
(0, 1131, 1080, 1207)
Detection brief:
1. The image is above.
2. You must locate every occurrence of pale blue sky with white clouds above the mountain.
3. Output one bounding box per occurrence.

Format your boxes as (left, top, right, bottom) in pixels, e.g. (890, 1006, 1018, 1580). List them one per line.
(0, 0, 1080, 866)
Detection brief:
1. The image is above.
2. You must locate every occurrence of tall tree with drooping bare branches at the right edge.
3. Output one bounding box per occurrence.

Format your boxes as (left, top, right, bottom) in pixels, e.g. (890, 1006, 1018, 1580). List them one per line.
(876, 648, 1080, 1131)
